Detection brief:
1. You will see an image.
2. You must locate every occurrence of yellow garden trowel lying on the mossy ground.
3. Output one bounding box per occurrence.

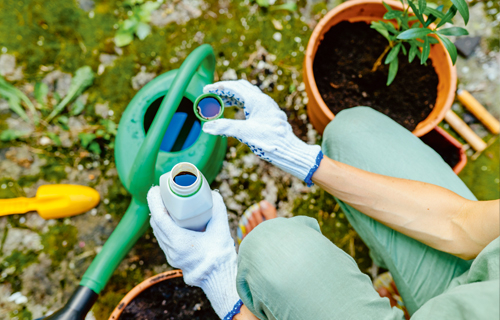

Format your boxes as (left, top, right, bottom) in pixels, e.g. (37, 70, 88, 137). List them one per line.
(0, 184, 99, 220)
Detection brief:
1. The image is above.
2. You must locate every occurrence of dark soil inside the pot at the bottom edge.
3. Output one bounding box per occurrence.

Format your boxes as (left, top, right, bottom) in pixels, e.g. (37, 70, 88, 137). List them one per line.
(119, 277, 220, 320)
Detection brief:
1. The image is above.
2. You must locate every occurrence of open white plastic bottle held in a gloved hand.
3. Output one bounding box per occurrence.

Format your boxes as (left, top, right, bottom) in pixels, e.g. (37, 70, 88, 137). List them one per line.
(160, 162, 213, 231)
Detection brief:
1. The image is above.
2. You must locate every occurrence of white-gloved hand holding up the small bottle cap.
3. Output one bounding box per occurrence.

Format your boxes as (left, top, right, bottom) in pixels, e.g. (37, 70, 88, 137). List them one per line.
(203, 80, 323, 186)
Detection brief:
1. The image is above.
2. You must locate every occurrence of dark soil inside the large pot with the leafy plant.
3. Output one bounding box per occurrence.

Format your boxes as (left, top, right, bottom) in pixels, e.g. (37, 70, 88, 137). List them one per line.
(313, 21, 439, 131)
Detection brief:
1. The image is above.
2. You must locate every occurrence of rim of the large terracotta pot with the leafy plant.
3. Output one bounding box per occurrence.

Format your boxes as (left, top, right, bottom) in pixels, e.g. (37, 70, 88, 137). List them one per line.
(304, 0, 457, 137)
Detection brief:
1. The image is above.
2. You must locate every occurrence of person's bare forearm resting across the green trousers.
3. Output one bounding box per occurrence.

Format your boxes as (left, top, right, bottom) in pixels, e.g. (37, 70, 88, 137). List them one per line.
(312, 157, 500, 259)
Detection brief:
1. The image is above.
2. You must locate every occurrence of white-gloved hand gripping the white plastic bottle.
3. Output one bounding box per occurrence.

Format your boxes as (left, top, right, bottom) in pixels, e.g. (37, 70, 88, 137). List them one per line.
(148, 187, 241, 319)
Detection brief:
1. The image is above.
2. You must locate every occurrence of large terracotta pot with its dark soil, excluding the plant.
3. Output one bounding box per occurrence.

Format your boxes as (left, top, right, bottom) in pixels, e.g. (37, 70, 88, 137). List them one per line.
(304, 0, 457, 136)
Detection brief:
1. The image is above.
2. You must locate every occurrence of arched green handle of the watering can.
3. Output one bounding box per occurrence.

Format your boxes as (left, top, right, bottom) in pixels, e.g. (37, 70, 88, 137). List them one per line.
(129, 44, 215, 203)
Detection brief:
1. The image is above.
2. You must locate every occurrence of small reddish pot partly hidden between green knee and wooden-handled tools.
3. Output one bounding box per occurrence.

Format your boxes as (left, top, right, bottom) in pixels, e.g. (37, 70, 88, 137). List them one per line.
(420, 127, 467, 174)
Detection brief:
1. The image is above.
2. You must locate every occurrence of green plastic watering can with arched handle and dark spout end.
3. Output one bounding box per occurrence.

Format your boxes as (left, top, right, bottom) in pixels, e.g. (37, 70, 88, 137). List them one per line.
(41, 44, 227, 320)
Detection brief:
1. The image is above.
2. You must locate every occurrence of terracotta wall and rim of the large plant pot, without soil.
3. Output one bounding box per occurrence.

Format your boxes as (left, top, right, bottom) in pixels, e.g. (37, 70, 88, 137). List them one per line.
(304, 0, 457, 137)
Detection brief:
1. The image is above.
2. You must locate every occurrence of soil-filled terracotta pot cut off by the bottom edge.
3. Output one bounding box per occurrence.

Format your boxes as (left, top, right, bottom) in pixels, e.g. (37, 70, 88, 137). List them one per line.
(109, 270, 220, 320)
